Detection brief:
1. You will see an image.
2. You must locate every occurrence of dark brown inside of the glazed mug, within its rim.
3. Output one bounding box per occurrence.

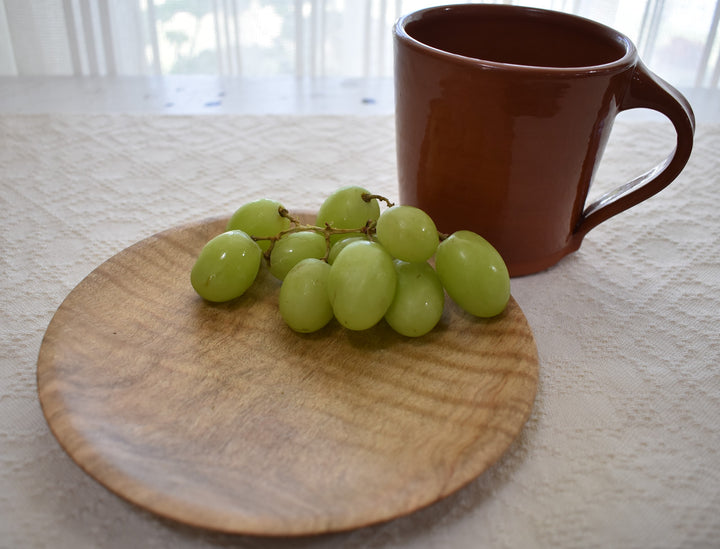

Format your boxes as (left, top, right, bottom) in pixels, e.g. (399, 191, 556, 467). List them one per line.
(399, 4, 631, 68)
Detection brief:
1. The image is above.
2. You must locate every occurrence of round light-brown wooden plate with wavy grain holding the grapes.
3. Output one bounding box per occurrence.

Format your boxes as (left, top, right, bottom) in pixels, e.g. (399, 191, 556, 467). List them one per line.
(37, 214, 538, 535)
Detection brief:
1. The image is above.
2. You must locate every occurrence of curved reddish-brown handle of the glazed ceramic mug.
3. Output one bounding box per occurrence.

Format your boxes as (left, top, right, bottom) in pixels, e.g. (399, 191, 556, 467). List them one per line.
(573, 62, 695, 240)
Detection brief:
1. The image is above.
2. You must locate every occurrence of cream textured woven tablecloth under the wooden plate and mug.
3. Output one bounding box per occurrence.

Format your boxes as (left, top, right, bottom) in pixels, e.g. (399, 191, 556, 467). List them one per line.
(0, 115, 720, 549)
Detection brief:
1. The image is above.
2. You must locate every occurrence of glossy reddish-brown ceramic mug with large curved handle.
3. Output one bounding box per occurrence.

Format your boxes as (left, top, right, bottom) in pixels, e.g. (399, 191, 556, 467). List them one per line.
(393, 4, 695, 276)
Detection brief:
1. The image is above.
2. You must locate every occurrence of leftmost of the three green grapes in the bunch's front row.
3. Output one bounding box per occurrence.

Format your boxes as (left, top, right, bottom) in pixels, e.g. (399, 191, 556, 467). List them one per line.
(278, 258, 333, 333)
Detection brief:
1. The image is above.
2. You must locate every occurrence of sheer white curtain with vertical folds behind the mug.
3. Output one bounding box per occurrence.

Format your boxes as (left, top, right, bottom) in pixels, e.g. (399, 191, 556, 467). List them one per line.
(0, 0, 720, 88)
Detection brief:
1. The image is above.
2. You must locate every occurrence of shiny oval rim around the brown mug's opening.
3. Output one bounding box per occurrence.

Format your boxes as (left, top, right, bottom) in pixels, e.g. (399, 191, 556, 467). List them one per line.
(393, 4, 637, 76)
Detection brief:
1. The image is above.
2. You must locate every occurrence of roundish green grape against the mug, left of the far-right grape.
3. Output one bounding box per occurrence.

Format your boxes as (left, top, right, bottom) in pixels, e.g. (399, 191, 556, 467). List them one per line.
(376, 206, 439, 262)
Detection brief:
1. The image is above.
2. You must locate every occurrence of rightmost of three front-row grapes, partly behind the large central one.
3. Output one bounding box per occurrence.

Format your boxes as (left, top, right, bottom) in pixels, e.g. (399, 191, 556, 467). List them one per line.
(385, 259, 445, 337)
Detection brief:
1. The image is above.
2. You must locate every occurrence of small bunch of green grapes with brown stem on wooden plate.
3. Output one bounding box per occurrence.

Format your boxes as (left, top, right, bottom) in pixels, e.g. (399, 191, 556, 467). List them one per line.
(190, 186, 510, 337)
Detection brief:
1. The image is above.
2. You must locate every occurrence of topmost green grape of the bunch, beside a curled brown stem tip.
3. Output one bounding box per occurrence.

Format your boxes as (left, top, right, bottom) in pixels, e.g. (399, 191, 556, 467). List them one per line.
(315, 186, 380, 243)
